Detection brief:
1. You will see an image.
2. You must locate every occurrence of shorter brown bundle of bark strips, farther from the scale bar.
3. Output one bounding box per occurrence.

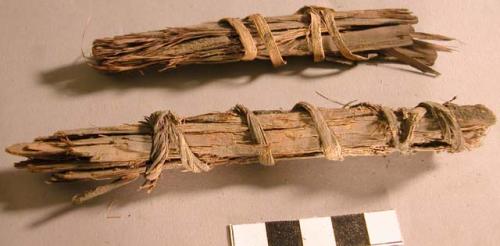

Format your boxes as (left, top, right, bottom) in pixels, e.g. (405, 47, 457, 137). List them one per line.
(89, 6, 451, 75)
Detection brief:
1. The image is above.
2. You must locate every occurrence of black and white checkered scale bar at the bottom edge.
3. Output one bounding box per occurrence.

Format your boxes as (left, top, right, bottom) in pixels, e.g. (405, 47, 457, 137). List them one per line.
(229, 210, 403, 246)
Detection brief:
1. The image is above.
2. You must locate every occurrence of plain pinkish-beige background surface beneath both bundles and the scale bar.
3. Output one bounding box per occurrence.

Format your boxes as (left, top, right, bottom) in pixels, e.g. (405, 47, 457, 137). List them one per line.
(0, 0, 500, 246)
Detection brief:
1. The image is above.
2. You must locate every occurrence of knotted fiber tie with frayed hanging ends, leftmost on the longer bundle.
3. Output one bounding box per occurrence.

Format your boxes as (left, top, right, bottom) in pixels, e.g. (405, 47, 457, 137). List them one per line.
(141, 111, 211, 192)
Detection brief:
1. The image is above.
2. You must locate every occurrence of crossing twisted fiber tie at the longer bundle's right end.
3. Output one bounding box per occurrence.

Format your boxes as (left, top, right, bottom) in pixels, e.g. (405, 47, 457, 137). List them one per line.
(352, 102, 465, 153)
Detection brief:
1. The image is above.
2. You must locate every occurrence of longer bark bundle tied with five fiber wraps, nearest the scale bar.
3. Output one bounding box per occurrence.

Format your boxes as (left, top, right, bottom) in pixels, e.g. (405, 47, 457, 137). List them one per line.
(6, 102, 495, 203)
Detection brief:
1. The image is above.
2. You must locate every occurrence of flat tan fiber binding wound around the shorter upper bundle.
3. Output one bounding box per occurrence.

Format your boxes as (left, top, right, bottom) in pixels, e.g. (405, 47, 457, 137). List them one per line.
(221, 6, 375, 67)
